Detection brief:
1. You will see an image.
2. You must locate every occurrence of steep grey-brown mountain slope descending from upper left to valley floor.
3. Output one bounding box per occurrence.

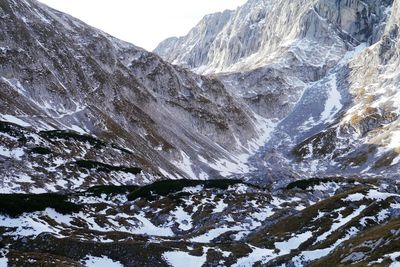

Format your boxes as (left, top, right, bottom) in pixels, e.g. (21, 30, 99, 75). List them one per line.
(0, 0, 276, 194)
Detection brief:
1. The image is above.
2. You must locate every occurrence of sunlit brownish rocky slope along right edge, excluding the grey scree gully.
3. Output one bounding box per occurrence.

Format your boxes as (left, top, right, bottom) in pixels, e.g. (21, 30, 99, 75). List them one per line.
(286, 1, 400, 180)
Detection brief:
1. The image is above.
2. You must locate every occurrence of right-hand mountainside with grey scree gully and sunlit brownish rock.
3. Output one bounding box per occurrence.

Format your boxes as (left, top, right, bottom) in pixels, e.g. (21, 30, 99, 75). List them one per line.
(255, 1, 400, 178)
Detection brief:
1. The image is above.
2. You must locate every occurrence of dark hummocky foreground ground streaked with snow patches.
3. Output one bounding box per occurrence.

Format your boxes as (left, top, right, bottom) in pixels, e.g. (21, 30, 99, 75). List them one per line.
(0, 177, 400, 266)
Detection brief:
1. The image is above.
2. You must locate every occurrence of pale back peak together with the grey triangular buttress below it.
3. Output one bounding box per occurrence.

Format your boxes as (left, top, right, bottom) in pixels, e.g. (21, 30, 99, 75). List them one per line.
(155, 0, 391, 125)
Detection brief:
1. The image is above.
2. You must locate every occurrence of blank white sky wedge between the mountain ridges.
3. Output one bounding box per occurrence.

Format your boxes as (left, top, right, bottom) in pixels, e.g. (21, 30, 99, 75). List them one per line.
(39, 0, 246, 51)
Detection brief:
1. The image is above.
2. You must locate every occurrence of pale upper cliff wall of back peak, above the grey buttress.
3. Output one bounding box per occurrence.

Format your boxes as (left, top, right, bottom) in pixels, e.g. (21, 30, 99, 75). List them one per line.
(155, 0, 392, 73)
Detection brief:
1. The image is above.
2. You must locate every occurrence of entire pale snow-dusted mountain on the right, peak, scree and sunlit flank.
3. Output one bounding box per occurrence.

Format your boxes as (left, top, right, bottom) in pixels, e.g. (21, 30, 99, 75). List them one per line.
(155, 0, 400, 182)
